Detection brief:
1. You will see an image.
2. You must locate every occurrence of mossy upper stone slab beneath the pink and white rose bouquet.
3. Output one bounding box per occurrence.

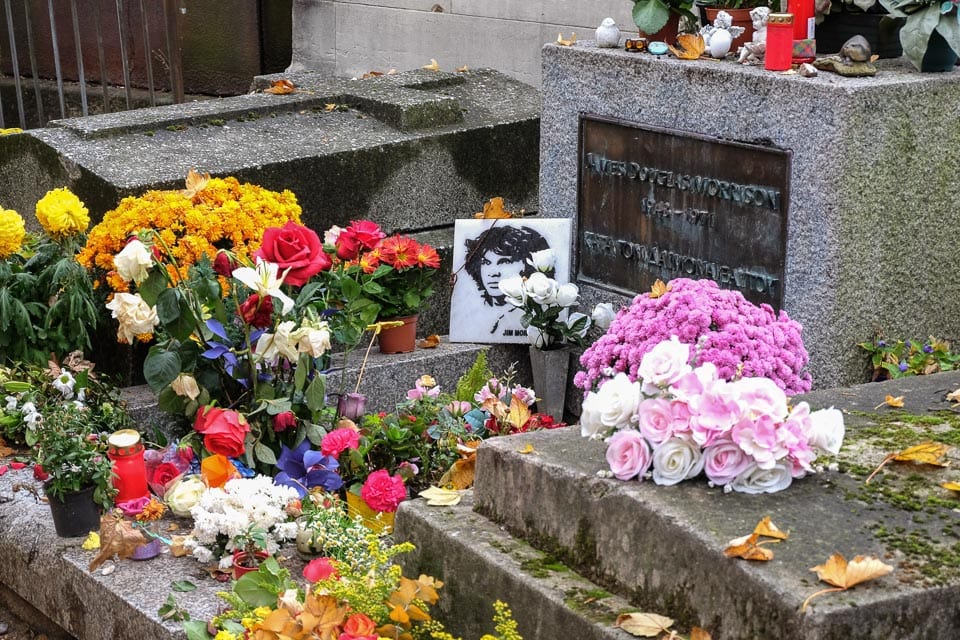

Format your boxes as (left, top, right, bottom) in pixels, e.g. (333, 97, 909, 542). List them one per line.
(468, 372, 960, 640)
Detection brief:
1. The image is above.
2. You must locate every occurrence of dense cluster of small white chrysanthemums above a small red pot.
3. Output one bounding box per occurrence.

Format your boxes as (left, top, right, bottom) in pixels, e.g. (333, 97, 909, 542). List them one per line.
(186, 475, 299, 562)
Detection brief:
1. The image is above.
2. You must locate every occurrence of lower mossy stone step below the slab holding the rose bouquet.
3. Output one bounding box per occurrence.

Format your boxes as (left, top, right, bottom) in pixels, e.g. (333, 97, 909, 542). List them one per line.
(394, 491, 633, 640)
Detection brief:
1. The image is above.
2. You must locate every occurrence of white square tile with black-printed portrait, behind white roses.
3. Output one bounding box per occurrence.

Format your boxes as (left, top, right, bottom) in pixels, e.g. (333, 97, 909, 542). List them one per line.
(450, 218, 571, 343)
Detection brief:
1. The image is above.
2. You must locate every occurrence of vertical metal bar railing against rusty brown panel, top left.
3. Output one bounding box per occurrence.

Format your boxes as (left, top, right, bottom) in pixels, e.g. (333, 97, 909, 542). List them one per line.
(0, 0, 185, 129)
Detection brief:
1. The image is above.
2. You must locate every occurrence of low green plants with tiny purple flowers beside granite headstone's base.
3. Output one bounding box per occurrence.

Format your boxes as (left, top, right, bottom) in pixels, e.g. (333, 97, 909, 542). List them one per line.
(857, 335, 960, 381)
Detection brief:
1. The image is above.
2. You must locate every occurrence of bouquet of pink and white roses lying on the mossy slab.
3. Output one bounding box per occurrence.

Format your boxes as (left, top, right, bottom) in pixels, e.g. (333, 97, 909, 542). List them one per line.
(581, 336, 844, 493)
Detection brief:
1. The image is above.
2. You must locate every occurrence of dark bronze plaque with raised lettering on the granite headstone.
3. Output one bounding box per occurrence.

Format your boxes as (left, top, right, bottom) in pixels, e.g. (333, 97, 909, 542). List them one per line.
(577, 115, 791, 309)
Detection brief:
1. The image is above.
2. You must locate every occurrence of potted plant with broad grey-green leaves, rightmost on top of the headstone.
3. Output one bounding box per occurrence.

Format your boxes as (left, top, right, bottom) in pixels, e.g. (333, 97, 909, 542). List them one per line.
(880, 0, 960, 71)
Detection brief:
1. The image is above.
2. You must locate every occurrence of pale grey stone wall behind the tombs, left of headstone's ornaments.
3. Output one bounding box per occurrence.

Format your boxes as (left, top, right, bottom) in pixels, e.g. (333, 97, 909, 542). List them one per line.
(292, 0, 636, 87)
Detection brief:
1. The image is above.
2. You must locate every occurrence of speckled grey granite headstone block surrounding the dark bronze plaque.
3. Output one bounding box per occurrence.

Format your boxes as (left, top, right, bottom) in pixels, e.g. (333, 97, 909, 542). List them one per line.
(540, 42, 960, 388)
